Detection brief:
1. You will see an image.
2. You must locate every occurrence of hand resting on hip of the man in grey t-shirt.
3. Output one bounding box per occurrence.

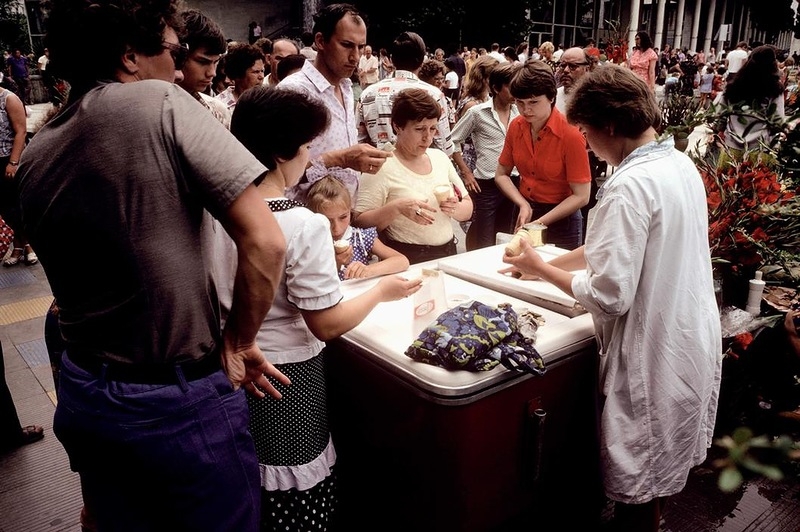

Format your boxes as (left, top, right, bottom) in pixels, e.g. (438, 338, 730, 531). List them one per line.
(222, 342, 292, 399)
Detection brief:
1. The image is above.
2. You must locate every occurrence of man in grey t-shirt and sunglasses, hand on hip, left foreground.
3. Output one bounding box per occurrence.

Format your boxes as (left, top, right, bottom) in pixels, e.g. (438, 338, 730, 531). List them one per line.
(17, 0, 289, 531)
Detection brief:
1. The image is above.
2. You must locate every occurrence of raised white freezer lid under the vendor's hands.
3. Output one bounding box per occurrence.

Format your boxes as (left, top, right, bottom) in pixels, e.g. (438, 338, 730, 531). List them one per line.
(438, 244, 586, 317)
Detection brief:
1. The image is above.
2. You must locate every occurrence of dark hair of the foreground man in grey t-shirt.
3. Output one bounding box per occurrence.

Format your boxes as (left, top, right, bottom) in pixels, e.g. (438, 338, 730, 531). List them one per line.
(44, 0, 183, 101)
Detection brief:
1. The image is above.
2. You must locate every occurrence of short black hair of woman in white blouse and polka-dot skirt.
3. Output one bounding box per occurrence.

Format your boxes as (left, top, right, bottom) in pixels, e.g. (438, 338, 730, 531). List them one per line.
(231, 85, 330, 170)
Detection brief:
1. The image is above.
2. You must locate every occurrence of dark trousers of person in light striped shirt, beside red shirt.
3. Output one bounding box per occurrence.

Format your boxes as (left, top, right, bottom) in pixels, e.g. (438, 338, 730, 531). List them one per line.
(466, 179, 516, 251)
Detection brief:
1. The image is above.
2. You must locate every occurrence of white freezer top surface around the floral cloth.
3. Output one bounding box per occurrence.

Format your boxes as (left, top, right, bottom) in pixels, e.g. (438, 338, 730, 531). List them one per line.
(342, 267, 594, 397)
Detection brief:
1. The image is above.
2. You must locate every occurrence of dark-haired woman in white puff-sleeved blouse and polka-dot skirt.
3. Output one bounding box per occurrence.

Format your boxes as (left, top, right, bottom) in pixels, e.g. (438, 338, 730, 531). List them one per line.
(212, 86, 420, 530)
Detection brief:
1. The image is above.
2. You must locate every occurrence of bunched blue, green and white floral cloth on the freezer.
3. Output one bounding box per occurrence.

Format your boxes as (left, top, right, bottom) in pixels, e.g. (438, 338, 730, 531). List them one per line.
(405, 301, 545, 375)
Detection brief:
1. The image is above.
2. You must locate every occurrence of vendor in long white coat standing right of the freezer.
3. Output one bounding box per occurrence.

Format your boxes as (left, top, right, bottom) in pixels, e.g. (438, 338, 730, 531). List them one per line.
(503, 65, 722, 531)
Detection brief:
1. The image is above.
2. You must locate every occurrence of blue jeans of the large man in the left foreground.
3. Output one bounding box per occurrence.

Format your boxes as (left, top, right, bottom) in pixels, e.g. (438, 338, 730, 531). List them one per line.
(53, 354, 261, 531)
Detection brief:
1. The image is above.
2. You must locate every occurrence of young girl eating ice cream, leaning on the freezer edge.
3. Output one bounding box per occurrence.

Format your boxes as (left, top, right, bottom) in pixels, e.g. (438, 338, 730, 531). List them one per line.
(306, 176, 408, 281)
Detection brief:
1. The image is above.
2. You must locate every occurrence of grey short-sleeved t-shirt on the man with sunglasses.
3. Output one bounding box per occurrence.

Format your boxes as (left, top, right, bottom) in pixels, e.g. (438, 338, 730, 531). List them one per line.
(17, 80, 266, 363)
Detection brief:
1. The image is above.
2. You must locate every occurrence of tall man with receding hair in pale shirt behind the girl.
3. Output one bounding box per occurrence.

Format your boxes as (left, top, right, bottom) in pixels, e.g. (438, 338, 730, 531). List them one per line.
(279, 4, 391, 204)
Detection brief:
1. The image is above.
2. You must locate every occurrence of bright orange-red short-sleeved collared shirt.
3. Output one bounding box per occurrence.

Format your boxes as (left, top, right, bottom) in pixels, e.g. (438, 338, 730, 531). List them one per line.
(498, 107, 592, 204)
